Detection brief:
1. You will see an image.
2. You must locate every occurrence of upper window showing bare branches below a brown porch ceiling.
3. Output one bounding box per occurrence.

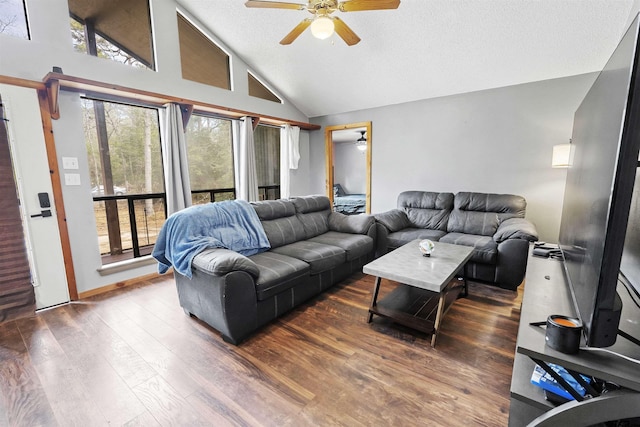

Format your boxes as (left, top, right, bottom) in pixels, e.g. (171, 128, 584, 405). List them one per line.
(67, 0, 154, 69)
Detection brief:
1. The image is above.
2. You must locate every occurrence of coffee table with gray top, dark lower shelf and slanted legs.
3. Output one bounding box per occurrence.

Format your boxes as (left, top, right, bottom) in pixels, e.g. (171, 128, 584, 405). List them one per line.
(362, 239, 473, 347)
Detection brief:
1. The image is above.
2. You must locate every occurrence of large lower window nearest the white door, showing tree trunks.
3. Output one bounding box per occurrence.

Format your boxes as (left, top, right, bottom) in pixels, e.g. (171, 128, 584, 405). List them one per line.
(82, 99, 166, 264)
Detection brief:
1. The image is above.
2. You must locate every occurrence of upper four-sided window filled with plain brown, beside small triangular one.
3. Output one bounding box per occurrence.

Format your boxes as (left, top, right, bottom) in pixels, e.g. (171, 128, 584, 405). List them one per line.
(177, 13, 231, 90)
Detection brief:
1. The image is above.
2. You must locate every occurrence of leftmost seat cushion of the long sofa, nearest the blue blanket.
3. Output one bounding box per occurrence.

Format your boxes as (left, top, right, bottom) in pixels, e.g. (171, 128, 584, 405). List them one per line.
(249, 251, 310, 301)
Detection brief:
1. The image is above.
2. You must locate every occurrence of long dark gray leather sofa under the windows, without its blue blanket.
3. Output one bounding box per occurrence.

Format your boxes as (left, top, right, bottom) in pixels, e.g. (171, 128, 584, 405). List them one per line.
(174, 196, 376, 344)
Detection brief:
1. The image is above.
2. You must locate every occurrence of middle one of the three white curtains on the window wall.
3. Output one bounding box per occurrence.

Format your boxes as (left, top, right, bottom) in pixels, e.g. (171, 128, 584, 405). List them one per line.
(233, 117, 260, 202)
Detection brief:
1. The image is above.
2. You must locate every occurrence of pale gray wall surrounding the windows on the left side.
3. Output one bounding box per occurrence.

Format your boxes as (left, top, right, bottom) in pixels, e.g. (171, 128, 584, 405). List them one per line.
(0, 0, 309, 293)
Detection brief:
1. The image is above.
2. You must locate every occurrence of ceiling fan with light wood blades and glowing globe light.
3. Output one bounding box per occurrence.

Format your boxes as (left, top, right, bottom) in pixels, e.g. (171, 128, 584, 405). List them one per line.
(244, 0, 400, 46)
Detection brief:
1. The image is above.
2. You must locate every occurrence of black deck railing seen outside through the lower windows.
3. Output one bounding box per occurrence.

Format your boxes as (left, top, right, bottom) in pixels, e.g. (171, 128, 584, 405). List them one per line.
(93, 185, 280, 265)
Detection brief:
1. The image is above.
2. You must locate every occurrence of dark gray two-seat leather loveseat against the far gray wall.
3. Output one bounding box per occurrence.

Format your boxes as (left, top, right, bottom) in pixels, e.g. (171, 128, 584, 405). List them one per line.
(374, 191, 538, 289)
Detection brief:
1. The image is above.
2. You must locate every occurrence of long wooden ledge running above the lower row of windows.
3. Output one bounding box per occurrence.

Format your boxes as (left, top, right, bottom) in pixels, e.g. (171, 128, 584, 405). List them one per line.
(39, 72, 320, 130)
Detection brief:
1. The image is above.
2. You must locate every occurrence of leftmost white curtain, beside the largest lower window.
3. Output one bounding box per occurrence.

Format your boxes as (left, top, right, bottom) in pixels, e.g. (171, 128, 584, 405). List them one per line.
(162, 103, 191, 215)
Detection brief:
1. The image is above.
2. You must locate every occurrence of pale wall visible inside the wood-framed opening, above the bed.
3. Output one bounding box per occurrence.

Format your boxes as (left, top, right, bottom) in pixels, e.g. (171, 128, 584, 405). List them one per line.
(333, 143, 367, 194)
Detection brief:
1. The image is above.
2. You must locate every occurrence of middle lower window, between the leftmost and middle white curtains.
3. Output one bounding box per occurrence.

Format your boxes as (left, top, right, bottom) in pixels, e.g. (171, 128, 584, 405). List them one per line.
(186, 114, 235, 205)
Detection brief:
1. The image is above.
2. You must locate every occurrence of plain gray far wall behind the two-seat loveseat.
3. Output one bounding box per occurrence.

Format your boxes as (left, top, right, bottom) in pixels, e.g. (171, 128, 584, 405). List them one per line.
(310, 73, 596, 242)
